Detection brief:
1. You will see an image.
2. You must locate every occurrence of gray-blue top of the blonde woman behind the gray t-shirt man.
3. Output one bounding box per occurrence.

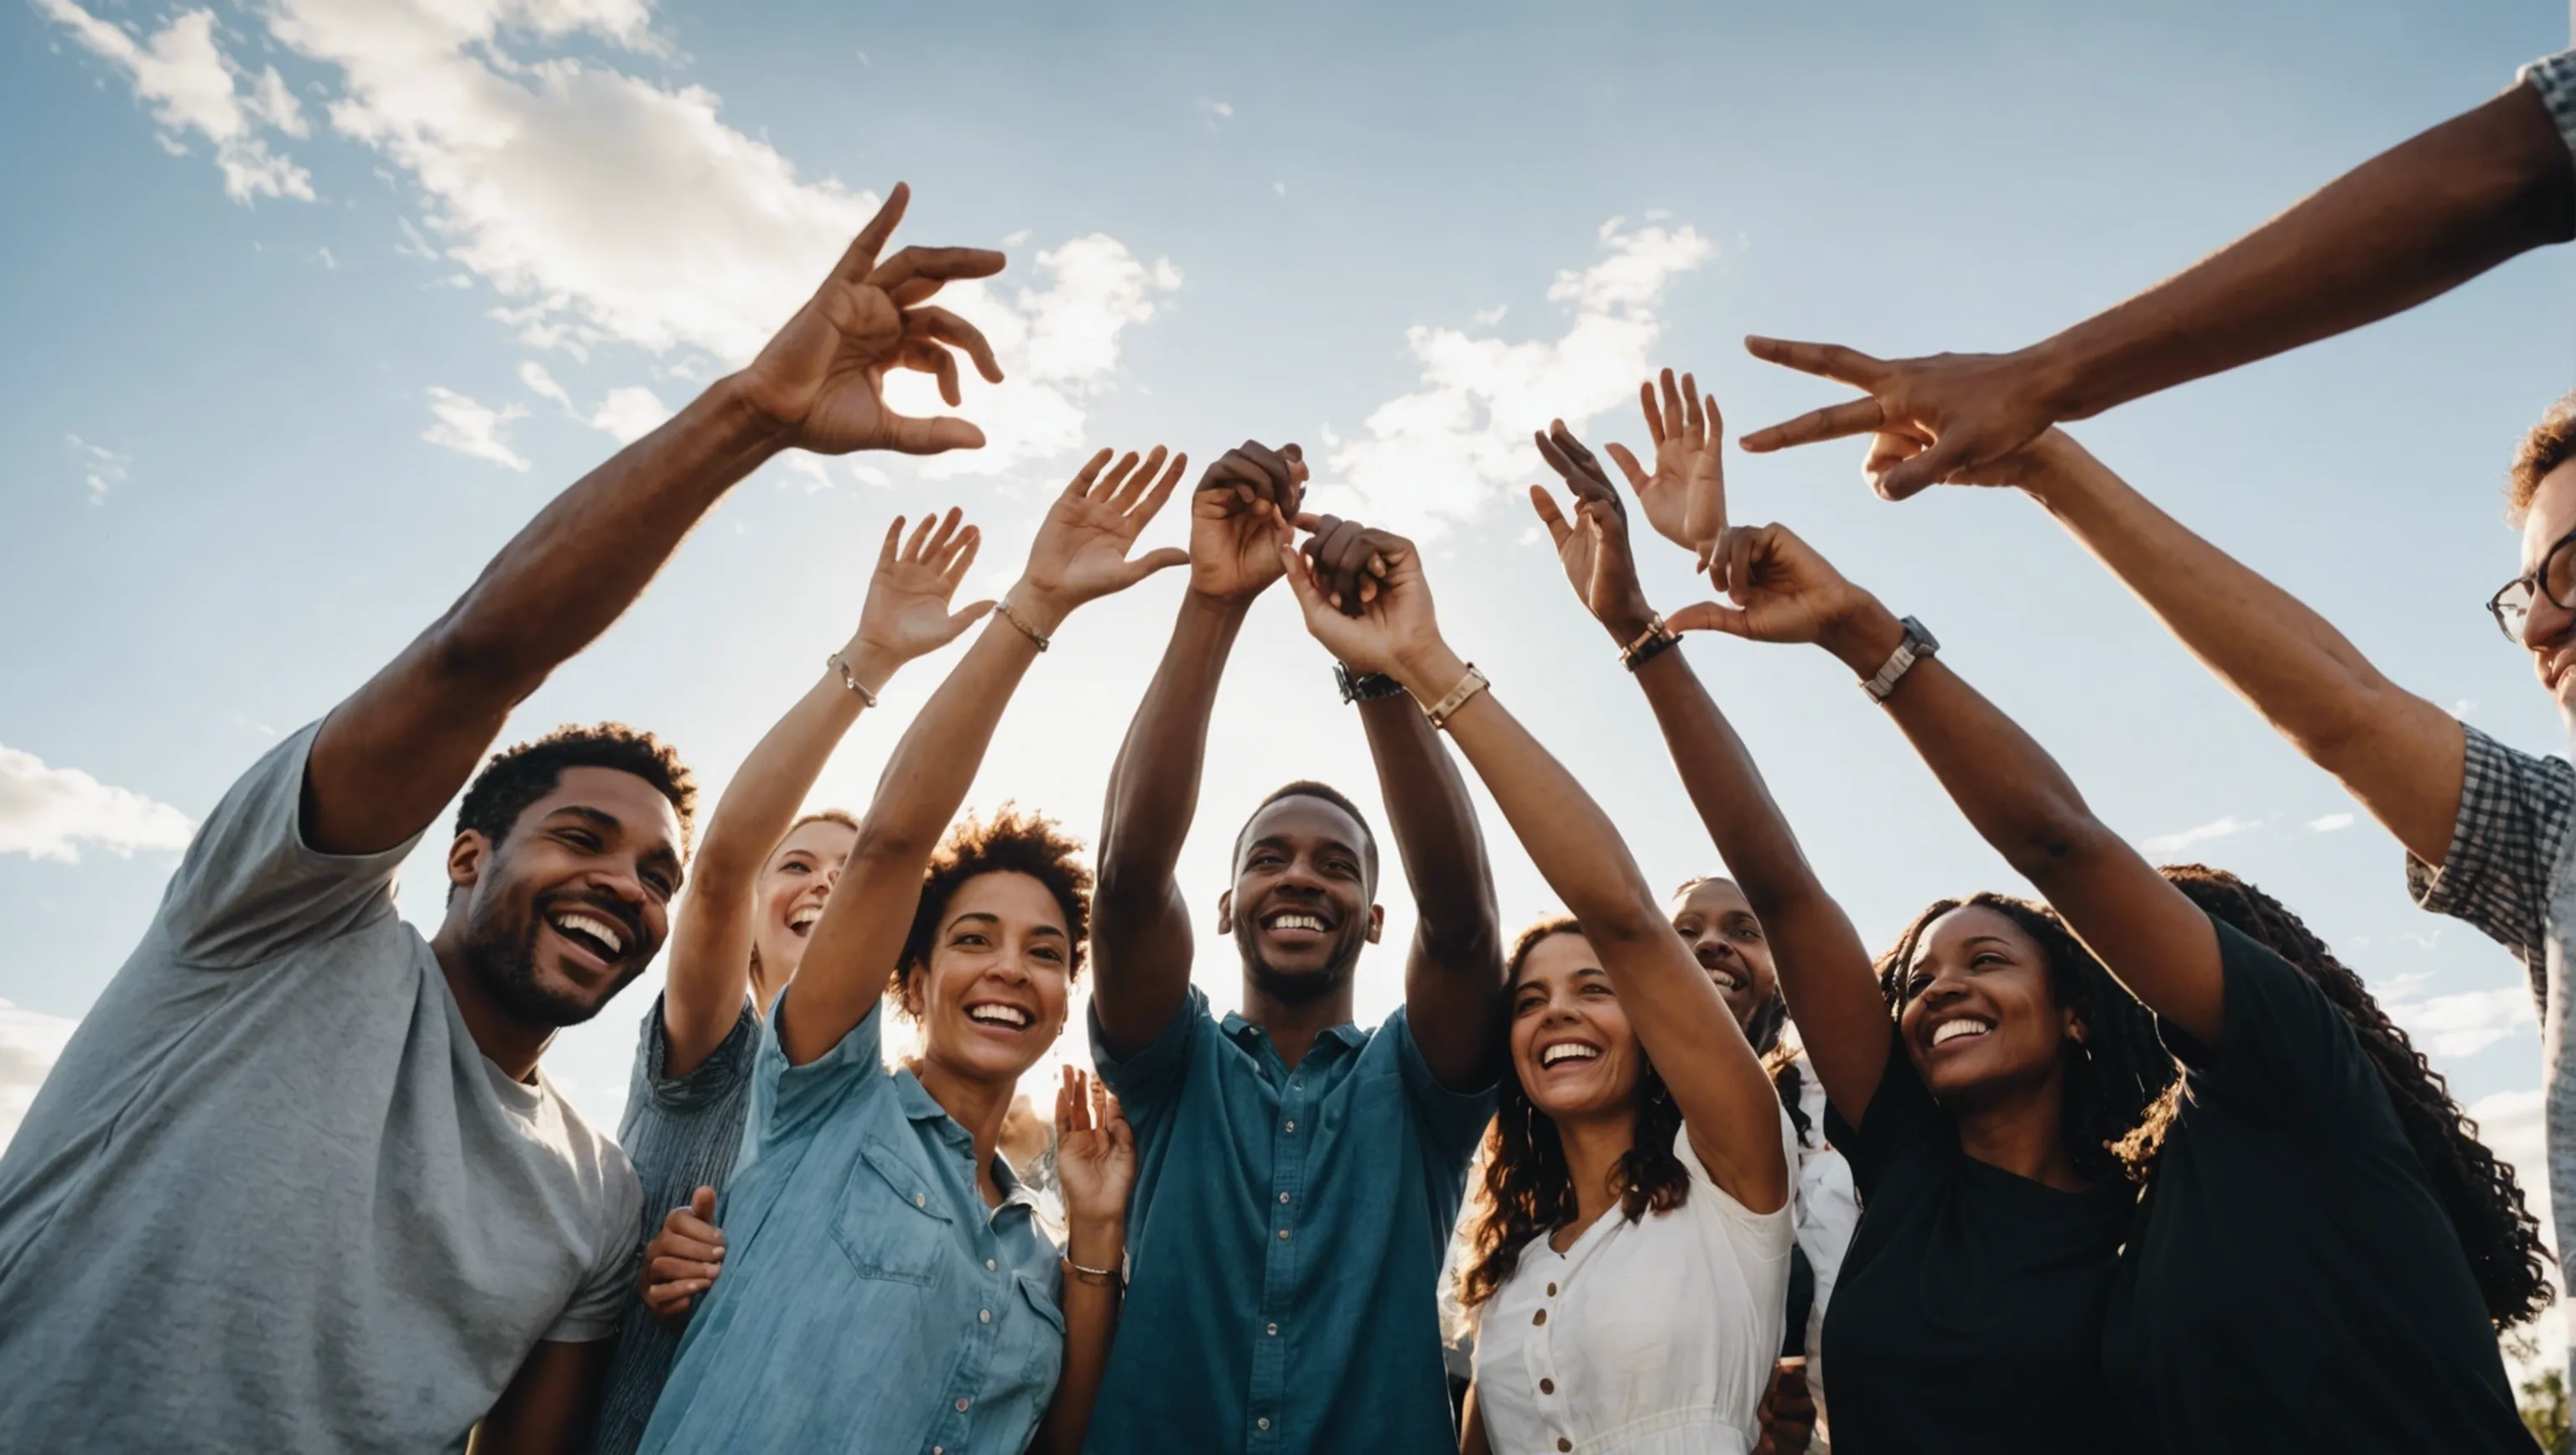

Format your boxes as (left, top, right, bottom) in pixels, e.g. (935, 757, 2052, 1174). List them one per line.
(589, 996, 760, 1455)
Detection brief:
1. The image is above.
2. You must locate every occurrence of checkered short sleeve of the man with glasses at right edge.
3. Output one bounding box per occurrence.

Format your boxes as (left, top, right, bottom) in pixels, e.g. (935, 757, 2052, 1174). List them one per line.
(2406, 724, 2576, 1002)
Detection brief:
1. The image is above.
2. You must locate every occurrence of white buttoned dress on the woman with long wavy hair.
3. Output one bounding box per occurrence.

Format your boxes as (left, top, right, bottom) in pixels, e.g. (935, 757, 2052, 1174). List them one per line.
(1476, 1113, 1798, 1455)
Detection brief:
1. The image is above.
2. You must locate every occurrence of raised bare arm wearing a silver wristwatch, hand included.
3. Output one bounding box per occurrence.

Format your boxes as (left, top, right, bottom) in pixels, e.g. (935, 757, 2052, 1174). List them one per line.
(1692, 525, 2225, 1046)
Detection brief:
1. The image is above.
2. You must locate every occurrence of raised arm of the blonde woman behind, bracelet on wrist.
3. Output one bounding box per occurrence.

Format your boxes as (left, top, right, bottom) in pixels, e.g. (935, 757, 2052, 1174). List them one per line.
(662, 510, 992, 1077)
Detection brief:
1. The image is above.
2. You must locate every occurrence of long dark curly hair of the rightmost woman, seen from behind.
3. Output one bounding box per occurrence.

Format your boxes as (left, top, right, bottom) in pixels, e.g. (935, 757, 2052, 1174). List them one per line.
(2163, 863, 2550, 1329)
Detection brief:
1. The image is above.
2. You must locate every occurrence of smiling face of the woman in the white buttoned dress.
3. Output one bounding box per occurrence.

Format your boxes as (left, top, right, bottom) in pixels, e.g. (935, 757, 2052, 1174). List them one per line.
(1512, 930, 1646, 1123)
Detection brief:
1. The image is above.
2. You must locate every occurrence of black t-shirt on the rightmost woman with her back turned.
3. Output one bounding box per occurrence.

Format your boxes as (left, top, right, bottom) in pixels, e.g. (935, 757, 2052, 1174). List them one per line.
(2112, 919, 2532, 1455)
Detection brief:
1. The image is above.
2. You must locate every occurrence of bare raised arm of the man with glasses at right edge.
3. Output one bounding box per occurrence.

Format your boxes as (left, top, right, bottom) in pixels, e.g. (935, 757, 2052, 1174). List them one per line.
(1926, 430, 2465, 868)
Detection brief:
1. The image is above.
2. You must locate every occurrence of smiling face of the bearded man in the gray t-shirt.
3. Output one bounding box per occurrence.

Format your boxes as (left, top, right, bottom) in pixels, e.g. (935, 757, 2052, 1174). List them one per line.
(449, 767, 680, 1027)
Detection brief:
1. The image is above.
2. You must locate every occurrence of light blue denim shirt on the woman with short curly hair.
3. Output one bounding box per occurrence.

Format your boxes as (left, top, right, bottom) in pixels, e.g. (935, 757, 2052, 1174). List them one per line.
(644, 986, 1064, 1455)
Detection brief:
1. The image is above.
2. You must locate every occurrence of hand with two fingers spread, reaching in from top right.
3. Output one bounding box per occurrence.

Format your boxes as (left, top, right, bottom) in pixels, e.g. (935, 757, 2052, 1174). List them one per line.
(1744, 337, 2061, 500)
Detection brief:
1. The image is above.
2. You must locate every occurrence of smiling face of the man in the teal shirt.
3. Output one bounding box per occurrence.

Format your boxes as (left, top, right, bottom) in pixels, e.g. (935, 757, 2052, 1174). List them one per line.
(1216, 793, 1384, 1002)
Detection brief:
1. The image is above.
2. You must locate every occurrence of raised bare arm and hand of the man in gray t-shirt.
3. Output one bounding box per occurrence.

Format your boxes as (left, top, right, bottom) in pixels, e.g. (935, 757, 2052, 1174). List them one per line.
(304, 185, 1002, 855)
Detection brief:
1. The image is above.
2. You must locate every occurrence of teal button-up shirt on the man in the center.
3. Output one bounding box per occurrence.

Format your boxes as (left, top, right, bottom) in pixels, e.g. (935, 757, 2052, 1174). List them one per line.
(1084, 989, 1494, 1455)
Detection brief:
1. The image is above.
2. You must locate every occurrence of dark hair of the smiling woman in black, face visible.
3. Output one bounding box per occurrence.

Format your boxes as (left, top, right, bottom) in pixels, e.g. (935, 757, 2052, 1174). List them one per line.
(1877, 894, 2179, 1182)
